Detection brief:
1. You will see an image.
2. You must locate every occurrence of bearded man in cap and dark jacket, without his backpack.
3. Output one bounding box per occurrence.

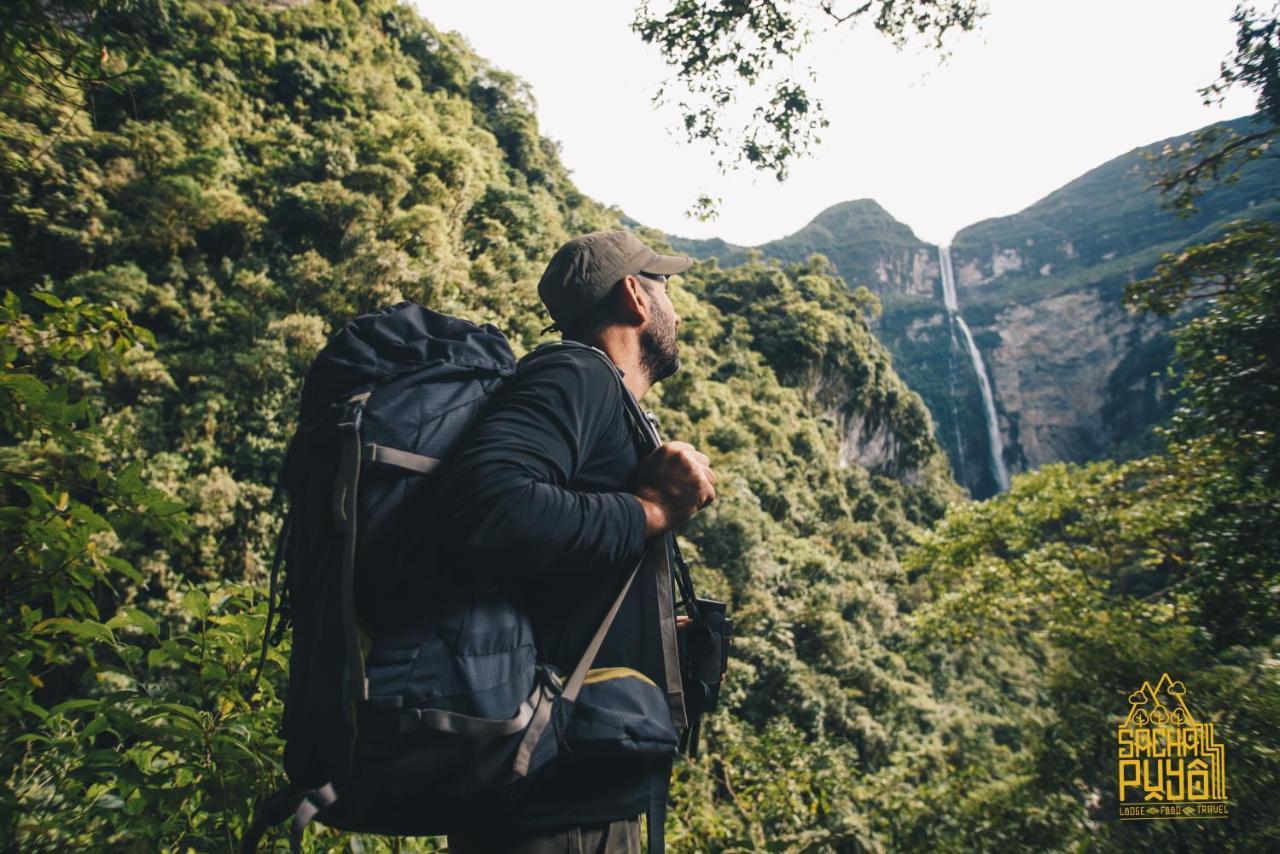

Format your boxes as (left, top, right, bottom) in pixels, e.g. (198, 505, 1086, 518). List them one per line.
(439, 232, 716, 854)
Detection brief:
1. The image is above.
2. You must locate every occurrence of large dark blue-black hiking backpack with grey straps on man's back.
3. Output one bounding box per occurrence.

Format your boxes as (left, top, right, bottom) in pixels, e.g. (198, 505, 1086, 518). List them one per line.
(242, 302, 692, 853)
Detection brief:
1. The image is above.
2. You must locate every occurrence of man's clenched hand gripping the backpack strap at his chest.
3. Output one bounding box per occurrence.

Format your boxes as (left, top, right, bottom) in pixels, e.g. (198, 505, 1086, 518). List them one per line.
(631, 442, 716, 536)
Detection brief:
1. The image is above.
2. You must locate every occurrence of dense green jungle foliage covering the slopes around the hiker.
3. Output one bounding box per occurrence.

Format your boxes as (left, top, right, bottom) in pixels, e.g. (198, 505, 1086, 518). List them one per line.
(0, 0, 1280, 851)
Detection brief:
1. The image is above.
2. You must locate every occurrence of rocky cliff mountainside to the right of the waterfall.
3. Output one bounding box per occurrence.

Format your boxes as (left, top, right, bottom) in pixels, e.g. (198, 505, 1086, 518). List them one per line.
(951, 119, 1280, 483)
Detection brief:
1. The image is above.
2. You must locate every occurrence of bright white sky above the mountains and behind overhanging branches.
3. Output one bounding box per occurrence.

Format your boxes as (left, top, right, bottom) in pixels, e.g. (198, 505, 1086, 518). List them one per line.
(416, 0, 1253, 246)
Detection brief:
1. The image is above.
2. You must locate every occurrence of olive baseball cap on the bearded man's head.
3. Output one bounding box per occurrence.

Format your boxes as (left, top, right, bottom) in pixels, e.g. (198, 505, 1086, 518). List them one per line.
(538, 230, 694, 333)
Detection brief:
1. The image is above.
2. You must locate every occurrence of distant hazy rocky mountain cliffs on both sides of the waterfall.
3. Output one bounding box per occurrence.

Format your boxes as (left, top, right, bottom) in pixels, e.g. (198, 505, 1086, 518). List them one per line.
(673, 113, 1280, 497)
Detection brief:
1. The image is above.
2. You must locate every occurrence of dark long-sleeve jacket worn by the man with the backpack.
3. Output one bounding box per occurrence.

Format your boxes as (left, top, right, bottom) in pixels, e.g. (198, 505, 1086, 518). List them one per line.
(438, 348, 660, 826)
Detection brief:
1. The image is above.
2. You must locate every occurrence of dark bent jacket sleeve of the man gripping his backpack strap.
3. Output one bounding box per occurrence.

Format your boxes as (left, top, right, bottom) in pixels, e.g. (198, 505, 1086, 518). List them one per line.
(438, 353, 645, 577)
